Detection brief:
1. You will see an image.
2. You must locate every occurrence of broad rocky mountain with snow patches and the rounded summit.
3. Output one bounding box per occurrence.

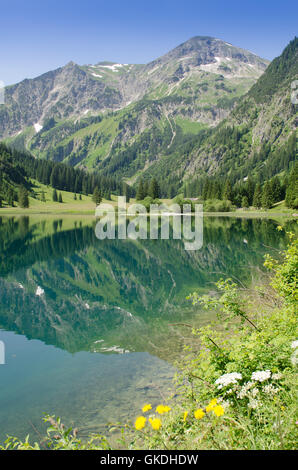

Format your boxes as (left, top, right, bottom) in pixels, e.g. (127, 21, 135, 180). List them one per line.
(0, 36, 268, 182)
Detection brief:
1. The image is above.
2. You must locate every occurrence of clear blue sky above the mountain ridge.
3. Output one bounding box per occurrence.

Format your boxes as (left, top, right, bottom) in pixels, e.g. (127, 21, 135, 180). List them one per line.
(0, 0, 298, 84)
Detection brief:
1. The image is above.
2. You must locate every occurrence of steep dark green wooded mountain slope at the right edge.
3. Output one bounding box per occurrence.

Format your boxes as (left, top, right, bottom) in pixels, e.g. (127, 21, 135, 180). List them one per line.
(177, 38, 298, 185)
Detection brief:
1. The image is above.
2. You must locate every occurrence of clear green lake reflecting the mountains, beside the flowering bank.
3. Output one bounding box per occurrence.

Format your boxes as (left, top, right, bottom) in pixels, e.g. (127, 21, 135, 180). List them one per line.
(0, 216, 291, 442)
